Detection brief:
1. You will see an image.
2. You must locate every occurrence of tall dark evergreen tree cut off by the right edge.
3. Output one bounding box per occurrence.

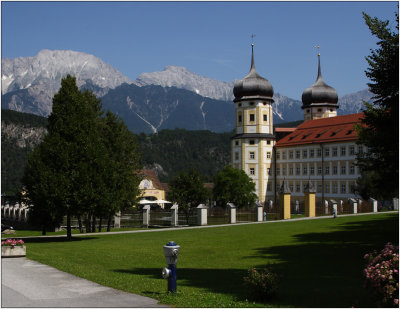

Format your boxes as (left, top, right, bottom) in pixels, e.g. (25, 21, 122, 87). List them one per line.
(355, 13, 399, 198)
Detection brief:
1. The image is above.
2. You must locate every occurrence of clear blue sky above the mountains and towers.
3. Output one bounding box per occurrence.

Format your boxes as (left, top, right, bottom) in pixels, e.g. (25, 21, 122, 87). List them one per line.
(1, 1, 398, 100)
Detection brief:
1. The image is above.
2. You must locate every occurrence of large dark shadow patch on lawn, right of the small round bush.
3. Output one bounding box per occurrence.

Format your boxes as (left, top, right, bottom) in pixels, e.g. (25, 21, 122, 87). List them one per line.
(247, 215, 399, 307)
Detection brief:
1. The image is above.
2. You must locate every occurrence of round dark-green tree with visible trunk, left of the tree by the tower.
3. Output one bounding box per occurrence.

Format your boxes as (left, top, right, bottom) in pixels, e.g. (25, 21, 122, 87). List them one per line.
(168, 168, 209, 224)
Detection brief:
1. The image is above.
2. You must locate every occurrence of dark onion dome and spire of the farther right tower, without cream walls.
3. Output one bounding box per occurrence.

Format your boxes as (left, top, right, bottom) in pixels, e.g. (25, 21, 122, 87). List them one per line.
(301, 54, 339, 109)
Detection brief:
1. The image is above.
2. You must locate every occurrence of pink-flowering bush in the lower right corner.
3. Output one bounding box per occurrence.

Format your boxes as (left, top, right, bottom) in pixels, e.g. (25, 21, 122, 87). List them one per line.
(364, 243, 399, 307)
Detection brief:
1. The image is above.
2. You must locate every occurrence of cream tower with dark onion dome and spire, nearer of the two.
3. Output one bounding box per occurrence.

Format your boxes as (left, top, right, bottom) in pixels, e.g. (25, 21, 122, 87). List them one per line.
(231, 44, 275, 202)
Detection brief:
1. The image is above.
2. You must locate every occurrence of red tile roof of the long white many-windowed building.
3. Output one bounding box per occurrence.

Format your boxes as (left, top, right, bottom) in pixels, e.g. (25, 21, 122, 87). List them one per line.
(276, 113, 363, 147)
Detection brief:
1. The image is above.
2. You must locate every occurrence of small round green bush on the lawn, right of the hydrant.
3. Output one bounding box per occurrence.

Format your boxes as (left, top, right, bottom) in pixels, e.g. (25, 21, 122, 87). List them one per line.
(243, 266, 279, 300)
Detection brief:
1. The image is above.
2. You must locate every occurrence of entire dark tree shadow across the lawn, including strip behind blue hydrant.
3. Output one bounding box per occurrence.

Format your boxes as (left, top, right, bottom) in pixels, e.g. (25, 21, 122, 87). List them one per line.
(114, 215, 399, 308)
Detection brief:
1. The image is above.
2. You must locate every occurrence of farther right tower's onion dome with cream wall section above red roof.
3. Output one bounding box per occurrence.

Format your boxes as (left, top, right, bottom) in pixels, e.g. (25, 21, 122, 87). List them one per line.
(301, 53, 339, 120)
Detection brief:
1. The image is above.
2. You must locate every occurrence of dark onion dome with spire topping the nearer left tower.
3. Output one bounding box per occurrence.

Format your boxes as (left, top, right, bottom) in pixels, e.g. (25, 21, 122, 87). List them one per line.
(233, 44, 274, 102)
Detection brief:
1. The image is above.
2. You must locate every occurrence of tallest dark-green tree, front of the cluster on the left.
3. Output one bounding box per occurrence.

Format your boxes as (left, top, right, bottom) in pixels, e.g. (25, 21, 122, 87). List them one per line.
(23, 75, 119, 238)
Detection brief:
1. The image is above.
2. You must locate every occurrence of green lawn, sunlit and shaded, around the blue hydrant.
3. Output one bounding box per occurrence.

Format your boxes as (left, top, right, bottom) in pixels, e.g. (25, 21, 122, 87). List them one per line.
(20, 213, 399, 307)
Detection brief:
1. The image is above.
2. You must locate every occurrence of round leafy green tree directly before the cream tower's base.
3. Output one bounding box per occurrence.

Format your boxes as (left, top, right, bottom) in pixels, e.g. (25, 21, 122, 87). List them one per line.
(213, 166, 257, 207)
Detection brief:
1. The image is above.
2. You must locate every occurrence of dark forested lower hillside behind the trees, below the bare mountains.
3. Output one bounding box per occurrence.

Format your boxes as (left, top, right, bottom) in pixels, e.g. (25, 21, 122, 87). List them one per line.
(1, 109, 301, 194)
